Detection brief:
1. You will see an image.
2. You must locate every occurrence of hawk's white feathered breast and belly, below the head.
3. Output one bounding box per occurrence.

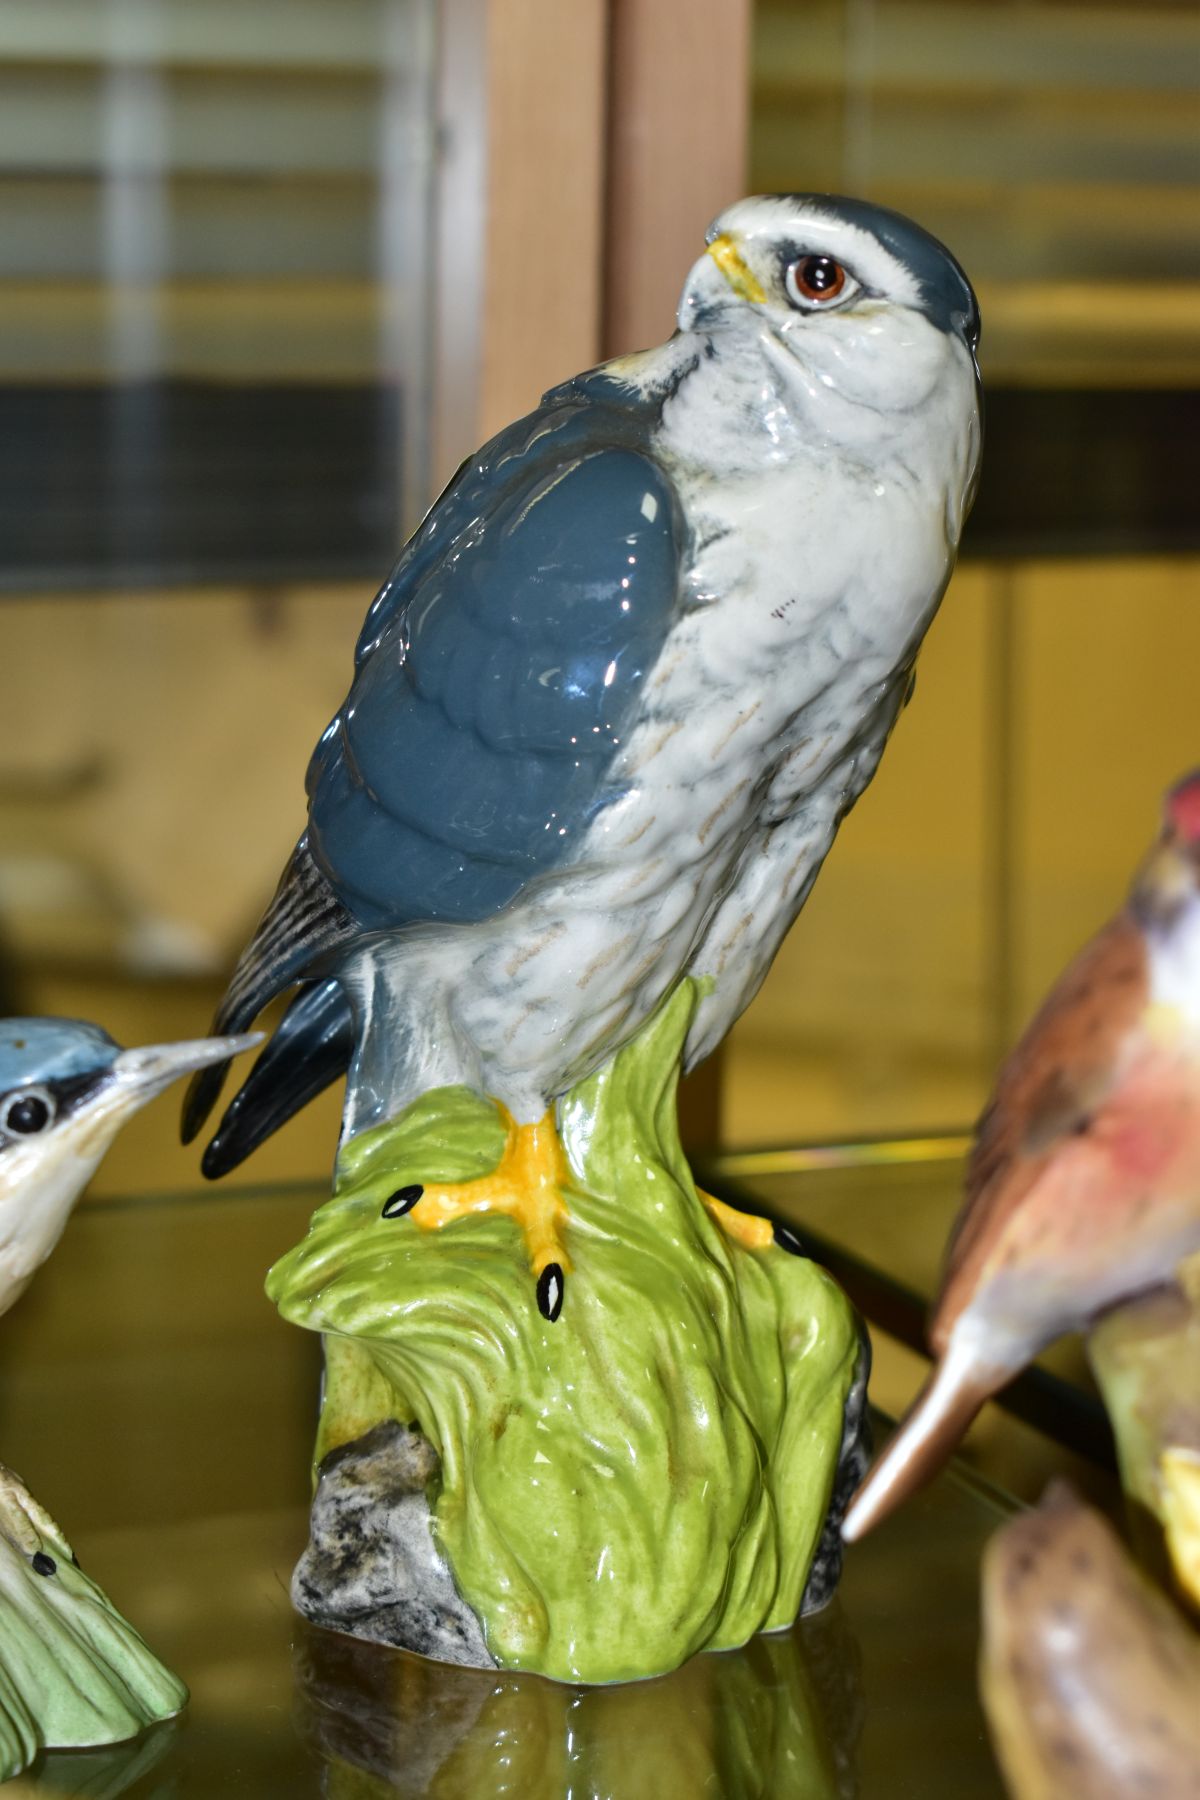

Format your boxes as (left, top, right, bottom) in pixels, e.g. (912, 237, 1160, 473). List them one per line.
(347, 309, 973, 1134)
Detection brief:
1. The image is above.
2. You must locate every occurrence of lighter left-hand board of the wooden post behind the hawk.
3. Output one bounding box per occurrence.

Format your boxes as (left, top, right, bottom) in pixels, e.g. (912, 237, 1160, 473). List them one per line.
(434, 0, 608, 482)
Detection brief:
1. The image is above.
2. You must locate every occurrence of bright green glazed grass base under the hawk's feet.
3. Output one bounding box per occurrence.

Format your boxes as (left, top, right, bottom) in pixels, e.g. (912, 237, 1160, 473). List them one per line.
(268, 983, 858, 1683)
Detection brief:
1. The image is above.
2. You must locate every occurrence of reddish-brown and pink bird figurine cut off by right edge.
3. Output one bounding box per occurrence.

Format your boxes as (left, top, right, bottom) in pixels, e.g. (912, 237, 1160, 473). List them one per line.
(842, 772, 1200, 1541)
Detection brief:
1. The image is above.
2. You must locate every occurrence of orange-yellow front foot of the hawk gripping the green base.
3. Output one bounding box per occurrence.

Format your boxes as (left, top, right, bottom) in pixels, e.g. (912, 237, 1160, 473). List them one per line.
(412, 1107, 570, 1276)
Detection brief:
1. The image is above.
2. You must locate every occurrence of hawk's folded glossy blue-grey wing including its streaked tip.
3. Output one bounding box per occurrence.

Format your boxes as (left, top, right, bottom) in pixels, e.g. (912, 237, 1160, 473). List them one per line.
(185, 378, 684, 1136)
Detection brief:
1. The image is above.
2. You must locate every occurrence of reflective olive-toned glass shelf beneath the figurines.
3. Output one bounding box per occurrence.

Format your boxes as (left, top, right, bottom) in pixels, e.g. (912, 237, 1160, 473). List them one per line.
(0, 1184, 1006, 1800)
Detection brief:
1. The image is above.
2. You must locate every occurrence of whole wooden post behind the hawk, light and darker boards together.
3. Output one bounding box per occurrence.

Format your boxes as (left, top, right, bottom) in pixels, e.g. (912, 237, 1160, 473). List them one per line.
(432, 0, 750, 1145)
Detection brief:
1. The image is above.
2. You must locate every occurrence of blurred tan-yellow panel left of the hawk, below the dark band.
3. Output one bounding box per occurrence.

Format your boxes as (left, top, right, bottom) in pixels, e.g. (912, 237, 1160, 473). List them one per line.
(0, 587, 371, 1193)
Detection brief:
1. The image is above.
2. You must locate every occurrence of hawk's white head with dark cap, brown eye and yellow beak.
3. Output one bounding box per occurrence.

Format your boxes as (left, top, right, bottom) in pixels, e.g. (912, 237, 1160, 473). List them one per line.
(678, 194, 979, 412)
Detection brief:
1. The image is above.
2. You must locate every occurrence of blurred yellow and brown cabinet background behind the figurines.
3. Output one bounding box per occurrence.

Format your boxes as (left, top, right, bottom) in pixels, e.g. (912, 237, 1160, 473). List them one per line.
(0, 0, 1200, 1193)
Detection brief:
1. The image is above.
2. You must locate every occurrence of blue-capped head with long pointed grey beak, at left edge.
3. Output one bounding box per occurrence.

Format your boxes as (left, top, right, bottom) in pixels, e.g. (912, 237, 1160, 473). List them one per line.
(0, 1019, 261, 1312)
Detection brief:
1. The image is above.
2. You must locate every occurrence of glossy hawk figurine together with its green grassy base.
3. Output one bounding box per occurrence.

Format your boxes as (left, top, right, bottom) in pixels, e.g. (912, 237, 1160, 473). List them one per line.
(185, 194, 979, 1683)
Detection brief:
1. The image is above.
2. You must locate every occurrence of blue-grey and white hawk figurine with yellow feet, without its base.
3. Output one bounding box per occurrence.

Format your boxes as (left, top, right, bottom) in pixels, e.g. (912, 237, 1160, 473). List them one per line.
(185, 194, 981, 1316)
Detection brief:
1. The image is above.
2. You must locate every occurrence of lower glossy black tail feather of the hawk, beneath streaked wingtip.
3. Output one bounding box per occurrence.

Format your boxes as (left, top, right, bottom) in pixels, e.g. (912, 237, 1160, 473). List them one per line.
(200, 981, 354, 1181)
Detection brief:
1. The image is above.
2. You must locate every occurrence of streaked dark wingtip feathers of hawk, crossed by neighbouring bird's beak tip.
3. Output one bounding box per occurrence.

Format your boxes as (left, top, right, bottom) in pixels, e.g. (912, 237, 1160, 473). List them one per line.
(180, 837, 358, 1144)
